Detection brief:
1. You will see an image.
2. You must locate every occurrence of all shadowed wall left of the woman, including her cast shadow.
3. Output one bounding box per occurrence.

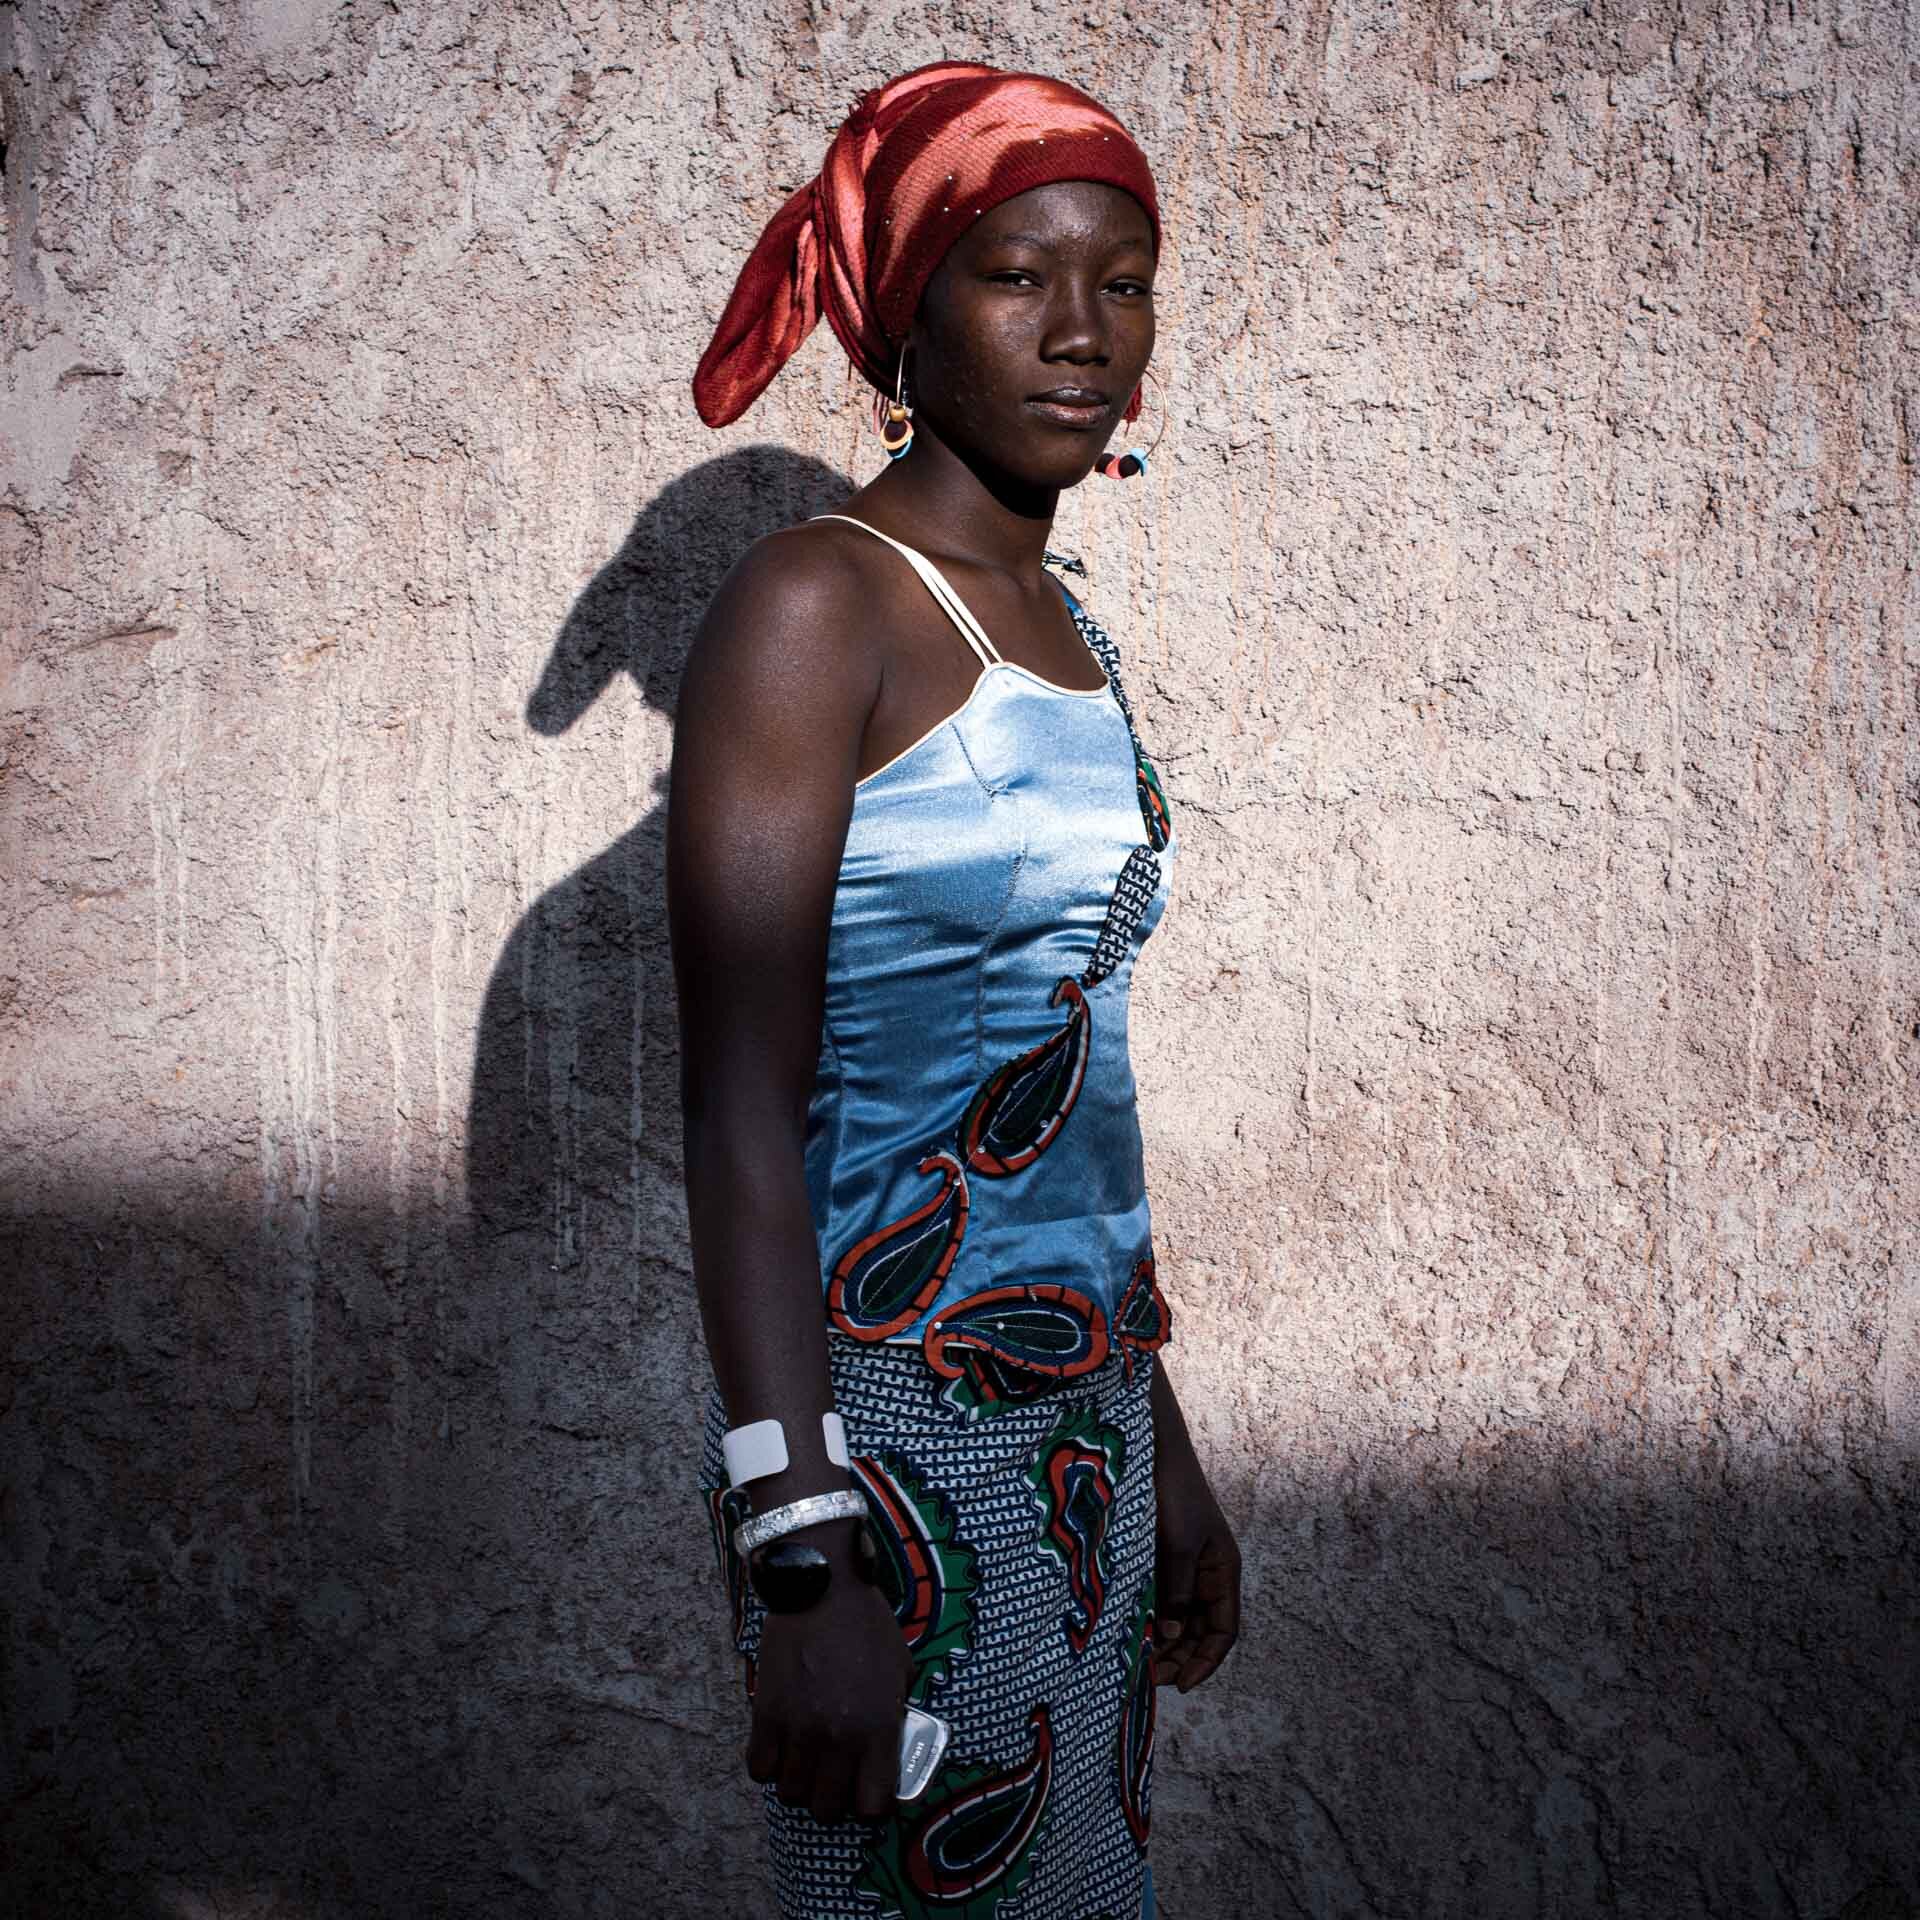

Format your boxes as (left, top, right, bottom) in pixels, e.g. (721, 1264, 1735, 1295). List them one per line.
(0, 445, 849, 1920)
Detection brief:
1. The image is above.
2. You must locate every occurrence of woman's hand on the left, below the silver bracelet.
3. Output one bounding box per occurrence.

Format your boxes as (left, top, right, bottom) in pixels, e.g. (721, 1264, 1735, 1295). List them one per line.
(747, 1534, 914, 1822)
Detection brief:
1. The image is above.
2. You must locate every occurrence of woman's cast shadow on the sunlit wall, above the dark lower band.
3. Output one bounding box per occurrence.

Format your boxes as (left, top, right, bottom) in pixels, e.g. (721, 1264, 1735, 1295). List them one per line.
(467, 445, 852, 1267)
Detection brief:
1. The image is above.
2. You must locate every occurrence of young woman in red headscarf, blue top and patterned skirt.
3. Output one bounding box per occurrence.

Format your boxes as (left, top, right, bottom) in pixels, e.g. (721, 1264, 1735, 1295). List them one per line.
(668, 63, 1238, 1920)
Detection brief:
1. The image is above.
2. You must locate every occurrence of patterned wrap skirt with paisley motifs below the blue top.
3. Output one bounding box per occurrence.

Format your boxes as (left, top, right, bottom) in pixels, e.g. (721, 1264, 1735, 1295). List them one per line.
(701, 1332, 1154, 1920)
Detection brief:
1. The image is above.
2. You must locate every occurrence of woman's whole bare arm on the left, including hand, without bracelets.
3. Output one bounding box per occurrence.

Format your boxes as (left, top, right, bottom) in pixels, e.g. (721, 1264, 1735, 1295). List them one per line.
(666, 528, 910, 1820)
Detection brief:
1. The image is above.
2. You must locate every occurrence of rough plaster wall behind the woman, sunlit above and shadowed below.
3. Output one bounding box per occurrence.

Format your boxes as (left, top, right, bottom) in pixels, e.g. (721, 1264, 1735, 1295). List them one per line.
(0, 0, 1920, 1920)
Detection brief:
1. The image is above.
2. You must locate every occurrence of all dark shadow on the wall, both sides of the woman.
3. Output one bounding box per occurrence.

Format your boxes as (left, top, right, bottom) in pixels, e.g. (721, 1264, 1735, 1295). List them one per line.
(0, 447, 1920, 1920)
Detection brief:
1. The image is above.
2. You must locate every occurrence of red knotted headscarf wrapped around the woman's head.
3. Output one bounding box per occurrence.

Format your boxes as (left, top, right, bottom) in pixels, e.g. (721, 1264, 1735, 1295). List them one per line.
(693, 60, 1160, 426)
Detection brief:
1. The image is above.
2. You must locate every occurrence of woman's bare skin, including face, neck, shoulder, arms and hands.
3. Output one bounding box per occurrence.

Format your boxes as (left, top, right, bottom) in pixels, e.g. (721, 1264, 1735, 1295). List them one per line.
(668, 180, 1240, 1820)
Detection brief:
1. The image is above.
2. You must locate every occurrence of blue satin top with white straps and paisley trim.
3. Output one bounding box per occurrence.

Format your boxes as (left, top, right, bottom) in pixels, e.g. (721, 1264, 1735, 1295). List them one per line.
(806, 515, 1175, 1411)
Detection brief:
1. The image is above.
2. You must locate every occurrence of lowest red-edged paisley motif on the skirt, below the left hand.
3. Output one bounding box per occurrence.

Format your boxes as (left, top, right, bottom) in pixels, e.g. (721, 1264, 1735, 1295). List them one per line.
(860, 1703, 1054, 1920)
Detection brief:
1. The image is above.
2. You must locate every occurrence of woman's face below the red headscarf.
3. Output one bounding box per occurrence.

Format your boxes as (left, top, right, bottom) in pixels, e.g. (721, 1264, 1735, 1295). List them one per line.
(906, 180, 1154, 488)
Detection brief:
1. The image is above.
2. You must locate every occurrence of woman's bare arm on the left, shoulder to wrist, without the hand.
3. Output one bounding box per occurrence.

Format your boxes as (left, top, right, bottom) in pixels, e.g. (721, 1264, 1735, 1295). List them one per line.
(666, 530, 877, 1509)
